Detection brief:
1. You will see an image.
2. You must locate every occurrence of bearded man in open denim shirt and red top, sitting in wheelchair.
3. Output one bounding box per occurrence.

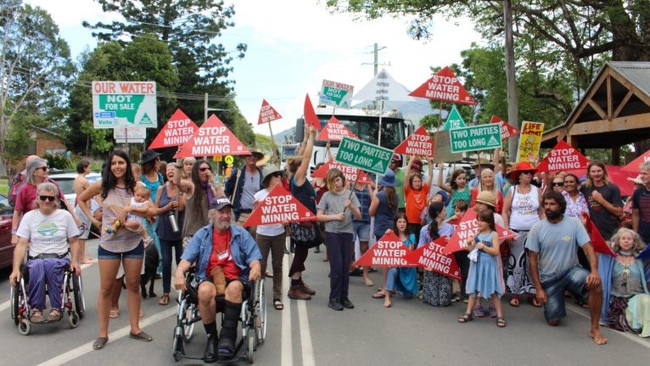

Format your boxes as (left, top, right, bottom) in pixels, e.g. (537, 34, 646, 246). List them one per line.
(174, 197, 262, 363)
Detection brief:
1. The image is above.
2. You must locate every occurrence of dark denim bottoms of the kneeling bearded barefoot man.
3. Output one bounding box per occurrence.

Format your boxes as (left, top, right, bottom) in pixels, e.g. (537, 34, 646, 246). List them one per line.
(542, 266, 589, 320)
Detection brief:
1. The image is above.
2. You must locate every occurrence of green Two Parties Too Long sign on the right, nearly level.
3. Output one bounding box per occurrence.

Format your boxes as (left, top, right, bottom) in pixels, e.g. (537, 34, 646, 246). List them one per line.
(449, 124, 501, 153)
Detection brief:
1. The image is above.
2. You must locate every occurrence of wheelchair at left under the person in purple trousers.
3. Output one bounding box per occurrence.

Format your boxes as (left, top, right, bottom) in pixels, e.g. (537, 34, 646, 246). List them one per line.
(11, 264, 86, 336)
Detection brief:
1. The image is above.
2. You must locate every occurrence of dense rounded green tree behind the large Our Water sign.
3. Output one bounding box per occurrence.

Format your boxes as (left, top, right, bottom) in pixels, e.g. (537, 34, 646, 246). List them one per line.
(67, 35, 179, 155)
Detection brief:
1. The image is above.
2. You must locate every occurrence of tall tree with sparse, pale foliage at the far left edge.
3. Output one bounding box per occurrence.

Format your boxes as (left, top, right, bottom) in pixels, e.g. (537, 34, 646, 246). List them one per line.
(0, 0, 75, 175)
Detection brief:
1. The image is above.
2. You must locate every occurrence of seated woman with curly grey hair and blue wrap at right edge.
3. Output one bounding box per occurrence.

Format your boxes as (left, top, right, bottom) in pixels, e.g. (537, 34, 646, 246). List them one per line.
(598, 228, 650, 337)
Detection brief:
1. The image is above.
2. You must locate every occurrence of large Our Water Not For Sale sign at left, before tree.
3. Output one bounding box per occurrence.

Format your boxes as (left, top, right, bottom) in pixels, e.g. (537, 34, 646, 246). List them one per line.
(92, 81, 158, 128)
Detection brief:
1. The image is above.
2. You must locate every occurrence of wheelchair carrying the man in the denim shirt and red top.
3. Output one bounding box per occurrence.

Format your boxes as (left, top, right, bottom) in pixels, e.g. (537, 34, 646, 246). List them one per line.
(172, 270, 267, 363)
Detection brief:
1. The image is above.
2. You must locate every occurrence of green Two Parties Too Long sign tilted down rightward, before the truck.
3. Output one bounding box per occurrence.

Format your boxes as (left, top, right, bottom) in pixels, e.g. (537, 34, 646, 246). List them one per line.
(336, 137, 393, 174)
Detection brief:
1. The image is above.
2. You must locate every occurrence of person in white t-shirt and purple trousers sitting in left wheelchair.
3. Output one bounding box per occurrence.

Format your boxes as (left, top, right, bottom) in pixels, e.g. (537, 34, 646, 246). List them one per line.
(9, 182, 81, 323)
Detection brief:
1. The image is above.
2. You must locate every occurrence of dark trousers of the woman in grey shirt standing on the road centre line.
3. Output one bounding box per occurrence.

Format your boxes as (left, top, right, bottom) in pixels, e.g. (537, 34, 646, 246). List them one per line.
(325, 232, 354, 299)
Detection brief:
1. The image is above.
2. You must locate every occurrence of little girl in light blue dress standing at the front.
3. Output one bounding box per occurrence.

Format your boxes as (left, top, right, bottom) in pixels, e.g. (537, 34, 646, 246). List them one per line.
(458, 210, 506, 328)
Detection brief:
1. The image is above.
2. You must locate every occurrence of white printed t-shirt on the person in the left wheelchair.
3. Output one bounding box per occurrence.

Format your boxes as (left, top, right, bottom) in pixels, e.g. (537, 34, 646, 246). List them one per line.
(16, 209, 79, 257)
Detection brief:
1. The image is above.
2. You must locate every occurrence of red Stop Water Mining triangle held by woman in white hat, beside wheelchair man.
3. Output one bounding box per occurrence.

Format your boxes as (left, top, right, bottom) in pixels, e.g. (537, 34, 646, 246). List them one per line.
(242, 184, 316, 227)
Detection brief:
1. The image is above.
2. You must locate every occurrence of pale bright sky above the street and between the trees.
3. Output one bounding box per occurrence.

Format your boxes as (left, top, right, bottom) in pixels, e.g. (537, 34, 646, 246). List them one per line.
(24, 0, 480, 135)
